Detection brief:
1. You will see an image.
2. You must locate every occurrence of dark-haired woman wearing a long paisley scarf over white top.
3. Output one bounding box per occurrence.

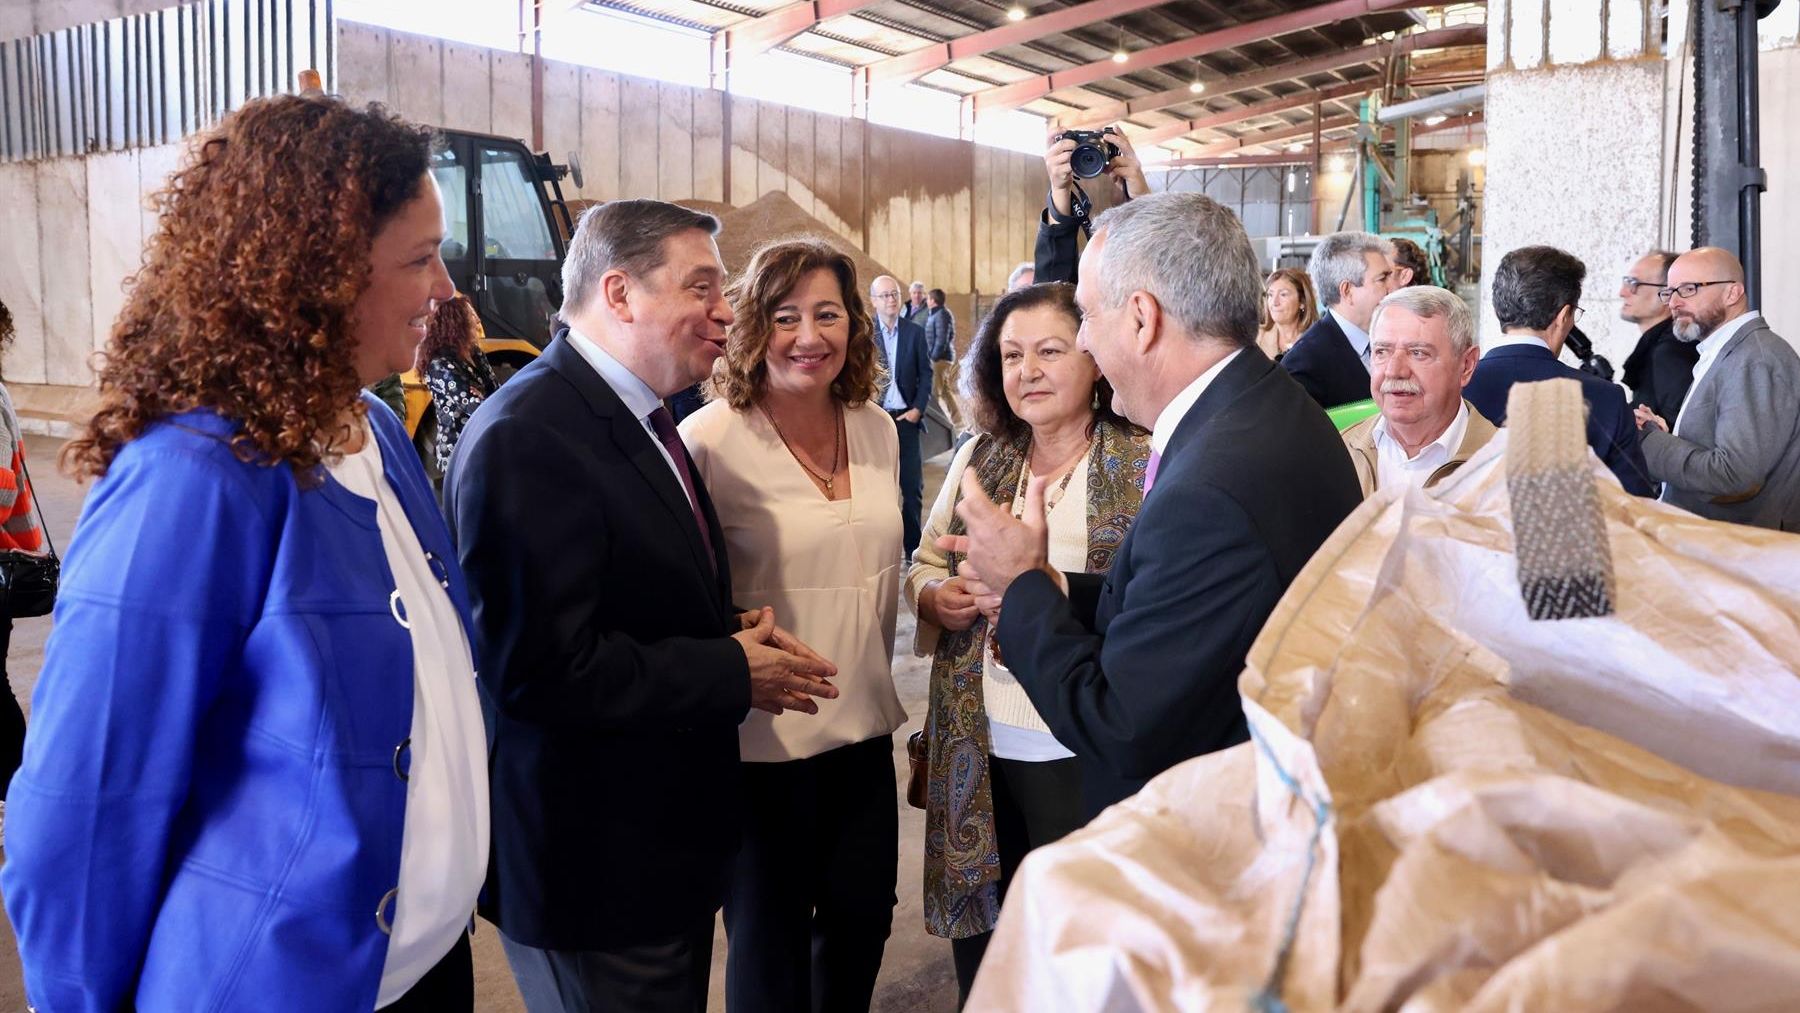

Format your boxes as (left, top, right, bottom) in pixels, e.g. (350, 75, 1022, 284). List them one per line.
(904, 282, 1150, 999)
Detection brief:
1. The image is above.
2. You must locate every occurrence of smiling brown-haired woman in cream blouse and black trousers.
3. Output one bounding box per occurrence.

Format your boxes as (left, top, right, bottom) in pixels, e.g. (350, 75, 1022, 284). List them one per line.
(680, 239, 905, 1011)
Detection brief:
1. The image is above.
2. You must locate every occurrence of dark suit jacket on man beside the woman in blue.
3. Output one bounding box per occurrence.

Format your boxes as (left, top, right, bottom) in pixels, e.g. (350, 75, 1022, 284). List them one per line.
(445, 331, 751, 950)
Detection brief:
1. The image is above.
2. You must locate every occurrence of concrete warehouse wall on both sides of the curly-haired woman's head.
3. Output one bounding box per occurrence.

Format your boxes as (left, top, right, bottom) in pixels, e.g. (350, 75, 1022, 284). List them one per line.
(0, 20, 1046, 395)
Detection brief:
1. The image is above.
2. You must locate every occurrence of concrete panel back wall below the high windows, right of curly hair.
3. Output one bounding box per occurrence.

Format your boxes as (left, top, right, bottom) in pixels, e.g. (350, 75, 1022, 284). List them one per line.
(338, 22, 1046, 305)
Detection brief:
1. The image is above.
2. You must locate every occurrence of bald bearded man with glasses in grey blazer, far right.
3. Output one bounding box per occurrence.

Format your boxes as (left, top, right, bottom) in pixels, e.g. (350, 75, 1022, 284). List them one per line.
(1638, 247, 1800, 531)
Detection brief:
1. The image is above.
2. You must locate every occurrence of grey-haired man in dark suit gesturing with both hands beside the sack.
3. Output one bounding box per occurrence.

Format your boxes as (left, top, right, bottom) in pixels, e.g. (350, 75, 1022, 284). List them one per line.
(941, 193, 1368, 815)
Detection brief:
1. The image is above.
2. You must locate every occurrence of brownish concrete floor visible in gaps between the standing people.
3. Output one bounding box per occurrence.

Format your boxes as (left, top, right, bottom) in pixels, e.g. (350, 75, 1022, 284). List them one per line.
(0, 437, 956, 1013)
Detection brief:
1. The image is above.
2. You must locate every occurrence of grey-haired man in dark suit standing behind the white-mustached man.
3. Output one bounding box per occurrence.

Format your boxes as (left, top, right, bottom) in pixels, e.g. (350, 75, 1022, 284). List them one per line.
(1282, 232, 1393, 408)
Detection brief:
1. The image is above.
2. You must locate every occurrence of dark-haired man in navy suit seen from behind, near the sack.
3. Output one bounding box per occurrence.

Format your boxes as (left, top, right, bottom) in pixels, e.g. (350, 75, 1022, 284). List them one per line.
(1463, 247, 1651, 497)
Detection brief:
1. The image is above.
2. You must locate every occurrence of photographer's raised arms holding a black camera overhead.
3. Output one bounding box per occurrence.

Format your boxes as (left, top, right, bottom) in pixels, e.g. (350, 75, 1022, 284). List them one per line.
(1035, 126, 1150, 284)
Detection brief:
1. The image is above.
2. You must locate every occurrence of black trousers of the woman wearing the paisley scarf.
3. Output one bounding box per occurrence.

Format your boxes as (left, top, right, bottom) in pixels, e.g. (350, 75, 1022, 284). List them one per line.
(950, 756, 1087, 1009)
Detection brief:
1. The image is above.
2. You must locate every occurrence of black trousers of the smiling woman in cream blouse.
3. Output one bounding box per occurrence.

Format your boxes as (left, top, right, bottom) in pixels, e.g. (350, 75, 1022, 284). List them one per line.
(725, 736, 900, 1013)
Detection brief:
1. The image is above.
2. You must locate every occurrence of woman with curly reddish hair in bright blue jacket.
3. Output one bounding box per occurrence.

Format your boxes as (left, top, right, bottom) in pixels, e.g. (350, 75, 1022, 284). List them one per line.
(0, 97, 488, 1011)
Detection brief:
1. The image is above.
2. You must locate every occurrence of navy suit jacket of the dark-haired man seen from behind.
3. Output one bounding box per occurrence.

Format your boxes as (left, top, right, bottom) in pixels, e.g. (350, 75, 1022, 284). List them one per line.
(1463, 345, 1651, 497)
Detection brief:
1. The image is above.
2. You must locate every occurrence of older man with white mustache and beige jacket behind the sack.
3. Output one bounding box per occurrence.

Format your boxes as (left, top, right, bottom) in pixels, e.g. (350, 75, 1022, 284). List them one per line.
(1345, 284, 1499, 498)
